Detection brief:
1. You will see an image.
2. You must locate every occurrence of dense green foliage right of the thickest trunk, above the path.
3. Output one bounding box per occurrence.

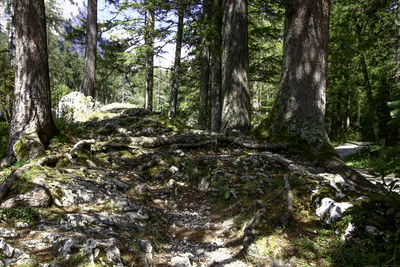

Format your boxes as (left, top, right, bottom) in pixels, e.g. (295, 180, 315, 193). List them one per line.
(325, 0, 398, 143)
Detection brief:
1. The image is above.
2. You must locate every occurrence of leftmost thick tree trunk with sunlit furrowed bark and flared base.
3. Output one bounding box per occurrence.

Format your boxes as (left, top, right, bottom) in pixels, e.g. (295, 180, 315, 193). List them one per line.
(7, 0, 55, 160)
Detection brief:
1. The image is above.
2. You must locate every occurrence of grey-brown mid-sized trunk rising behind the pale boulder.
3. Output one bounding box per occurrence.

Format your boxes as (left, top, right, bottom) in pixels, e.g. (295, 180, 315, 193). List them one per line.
(81, 0, 97, 97)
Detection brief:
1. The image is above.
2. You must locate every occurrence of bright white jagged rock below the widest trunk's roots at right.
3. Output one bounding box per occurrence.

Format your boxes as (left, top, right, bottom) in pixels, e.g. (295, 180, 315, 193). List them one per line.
(316, 198, 353, 224)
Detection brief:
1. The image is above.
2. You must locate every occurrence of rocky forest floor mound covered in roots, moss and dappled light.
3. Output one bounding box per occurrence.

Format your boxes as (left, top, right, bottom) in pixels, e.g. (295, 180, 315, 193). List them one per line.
(0, 105, 400, 266)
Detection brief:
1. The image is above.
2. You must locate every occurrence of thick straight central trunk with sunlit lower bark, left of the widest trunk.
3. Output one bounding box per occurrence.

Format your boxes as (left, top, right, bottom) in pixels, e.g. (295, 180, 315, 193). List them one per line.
(222, 0, 250, 131)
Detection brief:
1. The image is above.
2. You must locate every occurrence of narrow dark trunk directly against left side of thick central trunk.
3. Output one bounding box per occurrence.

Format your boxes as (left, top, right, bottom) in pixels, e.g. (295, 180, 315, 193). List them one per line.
(210, 0, 222, 132)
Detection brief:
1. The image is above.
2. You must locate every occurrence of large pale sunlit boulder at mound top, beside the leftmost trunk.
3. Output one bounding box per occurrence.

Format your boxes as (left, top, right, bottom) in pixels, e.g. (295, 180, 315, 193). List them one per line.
(55, 92, 101, 121)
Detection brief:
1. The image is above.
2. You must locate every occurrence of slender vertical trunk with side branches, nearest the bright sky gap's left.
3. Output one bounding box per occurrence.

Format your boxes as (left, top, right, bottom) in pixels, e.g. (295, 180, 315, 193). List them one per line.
(144, 0, 155, 111)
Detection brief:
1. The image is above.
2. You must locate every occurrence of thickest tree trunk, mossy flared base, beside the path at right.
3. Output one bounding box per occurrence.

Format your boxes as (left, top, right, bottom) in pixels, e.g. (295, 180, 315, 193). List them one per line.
(269, 0, 330, 145)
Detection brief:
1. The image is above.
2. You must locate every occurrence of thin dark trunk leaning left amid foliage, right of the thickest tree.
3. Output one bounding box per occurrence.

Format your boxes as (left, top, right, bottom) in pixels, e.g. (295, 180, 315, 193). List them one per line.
(360, 53, 380, 144)
